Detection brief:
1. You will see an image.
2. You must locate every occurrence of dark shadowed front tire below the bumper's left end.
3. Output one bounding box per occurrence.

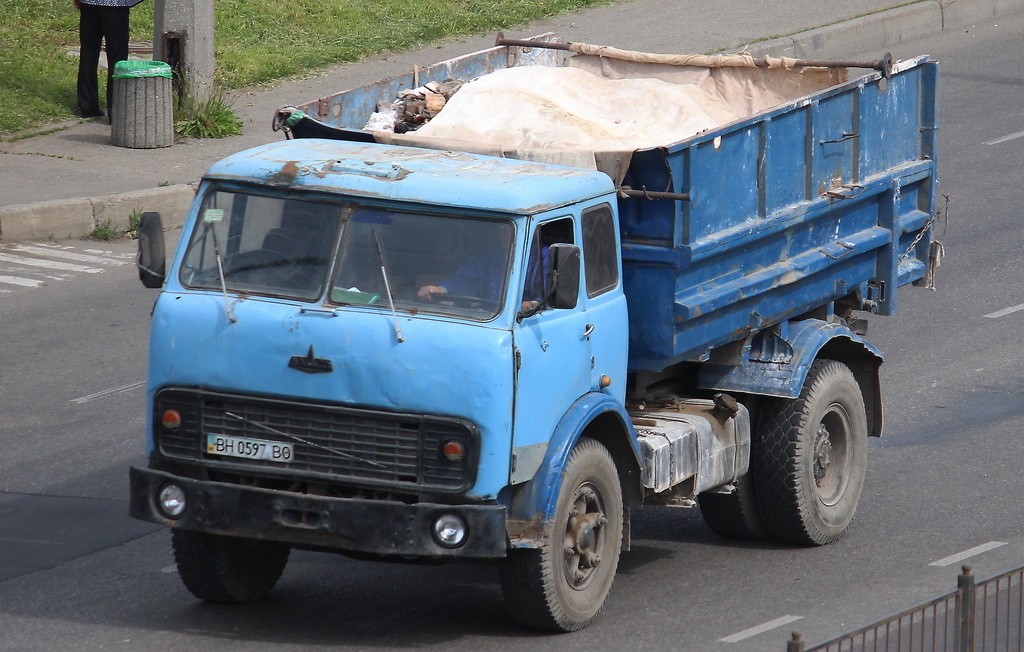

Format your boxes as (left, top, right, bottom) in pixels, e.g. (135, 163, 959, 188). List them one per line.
(171, 530, 291, 603)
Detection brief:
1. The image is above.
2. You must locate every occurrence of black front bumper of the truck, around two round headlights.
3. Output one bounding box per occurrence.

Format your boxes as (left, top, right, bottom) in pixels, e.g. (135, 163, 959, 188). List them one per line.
(129, 466, 508, 559)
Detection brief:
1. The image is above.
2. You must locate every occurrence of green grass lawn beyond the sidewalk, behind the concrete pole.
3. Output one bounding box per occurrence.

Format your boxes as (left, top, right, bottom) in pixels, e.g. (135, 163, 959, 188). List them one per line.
(0, 0, 615, 134)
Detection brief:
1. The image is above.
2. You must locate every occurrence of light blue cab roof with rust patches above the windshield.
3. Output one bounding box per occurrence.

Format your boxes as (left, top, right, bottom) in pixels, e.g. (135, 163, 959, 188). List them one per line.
(206, 138, 614, 214)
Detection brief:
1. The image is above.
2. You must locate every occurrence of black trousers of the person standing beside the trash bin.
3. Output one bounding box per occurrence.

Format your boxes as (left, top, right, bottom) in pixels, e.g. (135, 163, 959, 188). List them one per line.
(78, 2, 130, 117)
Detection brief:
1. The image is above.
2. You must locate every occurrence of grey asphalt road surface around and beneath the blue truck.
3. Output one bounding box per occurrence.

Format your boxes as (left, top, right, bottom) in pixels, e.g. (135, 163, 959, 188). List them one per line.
(0, 11, 1024, 652)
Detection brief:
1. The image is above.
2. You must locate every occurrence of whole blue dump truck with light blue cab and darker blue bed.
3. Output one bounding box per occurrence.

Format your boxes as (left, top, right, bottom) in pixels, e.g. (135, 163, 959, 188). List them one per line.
(130, 36, 938, 632)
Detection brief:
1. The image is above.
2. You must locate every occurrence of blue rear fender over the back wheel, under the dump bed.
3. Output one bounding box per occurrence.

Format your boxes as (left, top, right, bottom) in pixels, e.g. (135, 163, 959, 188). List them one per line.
(697, 319, 883, 437)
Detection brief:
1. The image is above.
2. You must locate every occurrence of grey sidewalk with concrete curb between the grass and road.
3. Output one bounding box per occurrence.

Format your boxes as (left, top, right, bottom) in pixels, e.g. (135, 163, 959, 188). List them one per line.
(0, 0, 1024, 242)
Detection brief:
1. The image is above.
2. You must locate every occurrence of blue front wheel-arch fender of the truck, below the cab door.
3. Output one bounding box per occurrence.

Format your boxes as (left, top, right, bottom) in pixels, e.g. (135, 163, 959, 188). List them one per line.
(507, 392, 643, 548)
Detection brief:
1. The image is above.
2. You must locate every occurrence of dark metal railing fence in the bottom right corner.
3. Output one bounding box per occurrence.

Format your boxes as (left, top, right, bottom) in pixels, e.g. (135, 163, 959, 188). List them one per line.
(786, 566, 1024, 652)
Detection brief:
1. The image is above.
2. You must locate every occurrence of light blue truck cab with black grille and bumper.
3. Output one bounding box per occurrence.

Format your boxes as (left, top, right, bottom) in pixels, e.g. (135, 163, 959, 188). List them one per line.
(132, 140, 638, 585)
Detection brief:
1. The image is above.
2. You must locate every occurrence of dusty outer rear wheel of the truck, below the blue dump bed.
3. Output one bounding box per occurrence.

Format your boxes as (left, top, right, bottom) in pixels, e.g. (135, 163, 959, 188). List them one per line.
(755, 359, 867, 546)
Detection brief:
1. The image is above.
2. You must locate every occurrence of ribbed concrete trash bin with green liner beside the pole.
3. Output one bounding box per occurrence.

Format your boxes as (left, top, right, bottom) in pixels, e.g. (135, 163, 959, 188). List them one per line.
(109, 59, 174, 149)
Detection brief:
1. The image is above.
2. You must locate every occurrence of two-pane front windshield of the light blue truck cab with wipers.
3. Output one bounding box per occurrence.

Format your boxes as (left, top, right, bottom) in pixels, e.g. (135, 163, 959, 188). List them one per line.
(179, 189, 514, 320)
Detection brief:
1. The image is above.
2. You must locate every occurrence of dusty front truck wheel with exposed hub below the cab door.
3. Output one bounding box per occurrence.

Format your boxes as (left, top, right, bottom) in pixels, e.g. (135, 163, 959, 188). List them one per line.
(501, 439, 623, 632)
